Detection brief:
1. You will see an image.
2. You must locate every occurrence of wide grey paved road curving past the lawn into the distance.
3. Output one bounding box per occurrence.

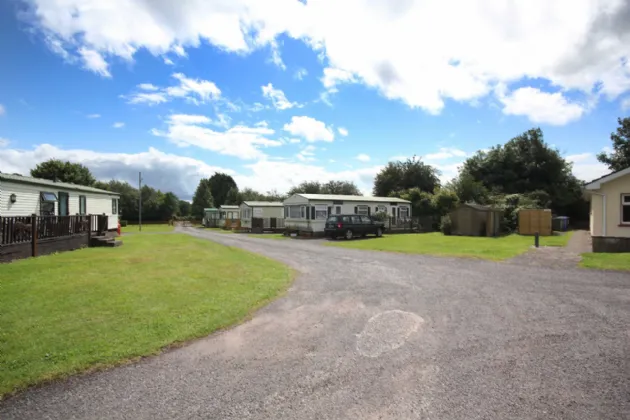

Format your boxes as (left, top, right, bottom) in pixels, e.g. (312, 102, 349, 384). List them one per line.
(0, 229, 630, 420)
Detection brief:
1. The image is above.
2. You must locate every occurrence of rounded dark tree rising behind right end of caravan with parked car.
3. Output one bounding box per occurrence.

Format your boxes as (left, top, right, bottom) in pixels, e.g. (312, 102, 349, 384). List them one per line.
(373, 156, 440, 197)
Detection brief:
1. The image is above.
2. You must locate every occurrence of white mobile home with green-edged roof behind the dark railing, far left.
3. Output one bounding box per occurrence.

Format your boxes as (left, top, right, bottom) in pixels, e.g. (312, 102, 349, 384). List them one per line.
(0, 173, 120, 230)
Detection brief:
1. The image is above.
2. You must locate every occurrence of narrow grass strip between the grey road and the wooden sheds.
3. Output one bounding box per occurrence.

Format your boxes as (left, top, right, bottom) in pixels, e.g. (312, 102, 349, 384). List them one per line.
(327, 232, 572, 261)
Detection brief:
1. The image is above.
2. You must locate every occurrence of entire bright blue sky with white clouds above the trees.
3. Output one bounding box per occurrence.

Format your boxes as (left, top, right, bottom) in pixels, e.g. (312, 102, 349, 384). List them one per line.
(0, 0, 630, 198)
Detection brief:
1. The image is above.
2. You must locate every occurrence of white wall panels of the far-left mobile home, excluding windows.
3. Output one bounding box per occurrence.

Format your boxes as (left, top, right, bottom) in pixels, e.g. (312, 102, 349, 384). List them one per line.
(0, 181, 118, 229)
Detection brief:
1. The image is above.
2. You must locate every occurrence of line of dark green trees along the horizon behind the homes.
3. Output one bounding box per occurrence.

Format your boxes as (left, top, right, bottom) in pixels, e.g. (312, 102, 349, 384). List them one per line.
(22, 117, 630, 225)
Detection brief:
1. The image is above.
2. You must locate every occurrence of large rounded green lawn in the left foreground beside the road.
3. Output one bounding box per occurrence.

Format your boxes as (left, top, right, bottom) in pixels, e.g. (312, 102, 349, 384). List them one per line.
(0, 234, 293, 399)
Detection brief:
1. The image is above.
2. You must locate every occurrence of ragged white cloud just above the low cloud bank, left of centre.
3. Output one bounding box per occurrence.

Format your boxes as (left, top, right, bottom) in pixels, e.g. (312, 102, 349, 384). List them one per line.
(151, 114, 282, 159)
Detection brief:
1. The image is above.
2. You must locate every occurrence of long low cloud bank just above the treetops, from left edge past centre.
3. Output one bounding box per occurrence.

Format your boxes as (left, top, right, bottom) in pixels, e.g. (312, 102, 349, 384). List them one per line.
(0, 144, 381, 200)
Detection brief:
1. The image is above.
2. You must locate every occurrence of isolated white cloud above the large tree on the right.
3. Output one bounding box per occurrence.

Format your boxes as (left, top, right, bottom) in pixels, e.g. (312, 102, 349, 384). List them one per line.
(499, 87, 587, 125)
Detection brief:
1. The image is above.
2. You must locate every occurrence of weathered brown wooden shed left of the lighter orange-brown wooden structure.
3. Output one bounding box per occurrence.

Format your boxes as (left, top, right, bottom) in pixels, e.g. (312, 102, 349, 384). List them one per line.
(450, 203, 503, 236)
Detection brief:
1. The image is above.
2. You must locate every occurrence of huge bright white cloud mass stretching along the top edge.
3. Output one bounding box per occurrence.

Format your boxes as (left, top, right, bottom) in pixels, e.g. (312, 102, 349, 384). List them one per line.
(22, 0, 630, 119)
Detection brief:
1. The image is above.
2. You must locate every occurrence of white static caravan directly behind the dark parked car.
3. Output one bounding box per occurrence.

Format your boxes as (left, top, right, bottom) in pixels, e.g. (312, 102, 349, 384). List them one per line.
(283, 194, 411, 234)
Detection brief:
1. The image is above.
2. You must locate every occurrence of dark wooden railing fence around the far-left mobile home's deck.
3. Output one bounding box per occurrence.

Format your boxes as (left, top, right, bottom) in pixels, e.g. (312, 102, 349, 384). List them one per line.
(0, 214, 108, 262)
